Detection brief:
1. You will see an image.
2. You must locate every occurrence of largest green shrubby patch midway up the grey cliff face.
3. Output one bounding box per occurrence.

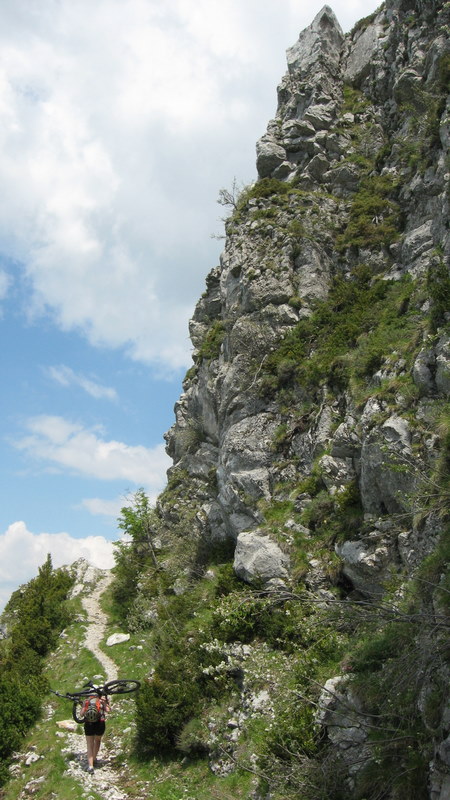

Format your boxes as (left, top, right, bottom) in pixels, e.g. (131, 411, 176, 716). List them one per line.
(261, 265, 421, 404)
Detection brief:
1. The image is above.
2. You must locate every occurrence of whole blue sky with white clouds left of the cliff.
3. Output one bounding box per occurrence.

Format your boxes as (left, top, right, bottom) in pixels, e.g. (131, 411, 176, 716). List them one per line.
(0, 0, 379, 609)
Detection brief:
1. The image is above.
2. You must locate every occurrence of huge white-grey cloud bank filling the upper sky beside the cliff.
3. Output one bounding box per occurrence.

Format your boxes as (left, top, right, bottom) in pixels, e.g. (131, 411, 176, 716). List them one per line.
(0, 0, 382, 368)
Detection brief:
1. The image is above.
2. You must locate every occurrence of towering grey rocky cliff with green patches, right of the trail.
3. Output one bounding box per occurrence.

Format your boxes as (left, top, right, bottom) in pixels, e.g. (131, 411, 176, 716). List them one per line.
(127, 0, 450, 800)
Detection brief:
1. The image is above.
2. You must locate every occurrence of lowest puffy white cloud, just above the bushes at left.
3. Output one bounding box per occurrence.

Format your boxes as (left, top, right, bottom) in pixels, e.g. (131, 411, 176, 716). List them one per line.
(0, 521, 114, 611)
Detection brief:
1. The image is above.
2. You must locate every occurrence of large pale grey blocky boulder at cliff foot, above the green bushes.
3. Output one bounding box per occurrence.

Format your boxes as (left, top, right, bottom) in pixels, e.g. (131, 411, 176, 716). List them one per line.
(233, 530, 289, 583)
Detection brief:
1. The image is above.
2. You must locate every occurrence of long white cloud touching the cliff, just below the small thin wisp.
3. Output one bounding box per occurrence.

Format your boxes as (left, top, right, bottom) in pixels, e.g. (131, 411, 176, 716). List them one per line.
(14, 415, 172, 484)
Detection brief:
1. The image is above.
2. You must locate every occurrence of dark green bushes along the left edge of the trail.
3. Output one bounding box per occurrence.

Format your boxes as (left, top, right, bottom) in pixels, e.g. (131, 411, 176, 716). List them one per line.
(0, 556, 73, 785)
